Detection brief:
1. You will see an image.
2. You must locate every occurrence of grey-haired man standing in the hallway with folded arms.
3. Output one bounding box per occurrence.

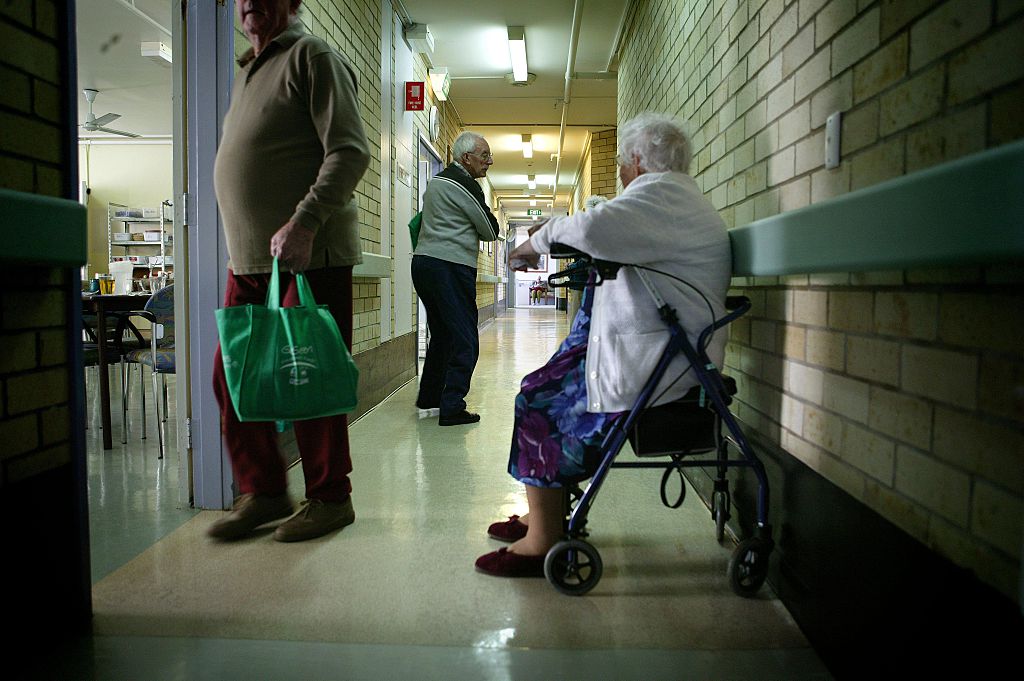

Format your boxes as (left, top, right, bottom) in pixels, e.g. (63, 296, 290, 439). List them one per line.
(413, 132, 498, 426)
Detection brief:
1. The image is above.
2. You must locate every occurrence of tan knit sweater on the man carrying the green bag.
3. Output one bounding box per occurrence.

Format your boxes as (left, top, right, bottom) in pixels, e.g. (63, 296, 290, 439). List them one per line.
(214, 20, 370, 274)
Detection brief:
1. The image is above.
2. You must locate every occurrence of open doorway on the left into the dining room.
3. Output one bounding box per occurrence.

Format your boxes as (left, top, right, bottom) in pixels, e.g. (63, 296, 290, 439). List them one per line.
(75, 0, 195, 581)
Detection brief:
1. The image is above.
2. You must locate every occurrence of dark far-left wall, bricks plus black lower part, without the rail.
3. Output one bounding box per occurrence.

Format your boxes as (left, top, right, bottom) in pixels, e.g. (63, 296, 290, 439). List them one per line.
(0, 0, 91, 659)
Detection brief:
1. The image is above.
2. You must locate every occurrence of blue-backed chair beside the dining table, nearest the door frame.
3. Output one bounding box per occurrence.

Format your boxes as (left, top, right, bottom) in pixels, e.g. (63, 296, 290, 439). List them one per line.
(125, 285, 175, 459)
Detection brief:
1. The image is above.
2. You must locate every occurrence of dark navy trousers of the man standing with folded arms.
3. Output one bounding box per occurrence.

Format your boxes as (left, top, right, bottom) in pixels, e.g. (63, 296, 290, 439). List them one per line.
(413, 255, 480, 416)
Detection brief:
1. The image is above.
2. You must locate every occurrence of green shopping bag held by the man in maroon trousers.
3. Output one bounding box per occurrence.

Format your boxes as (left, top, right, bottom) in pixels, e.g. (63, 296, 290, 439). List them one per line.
(216, 258, 359, 421)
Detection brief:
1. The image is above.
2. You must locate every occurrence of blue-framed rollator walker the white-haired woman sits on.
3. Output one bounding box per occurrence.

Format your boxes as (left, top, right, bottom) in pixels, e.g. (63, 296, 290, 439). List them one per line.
(544, 244, 774, 597)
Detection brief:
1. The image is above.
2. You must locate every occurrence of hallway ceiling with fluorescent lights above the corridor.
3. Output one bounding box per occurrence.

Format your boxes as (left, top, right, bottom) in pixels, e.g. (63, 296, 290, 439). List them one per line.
(403, 0, 628, 220)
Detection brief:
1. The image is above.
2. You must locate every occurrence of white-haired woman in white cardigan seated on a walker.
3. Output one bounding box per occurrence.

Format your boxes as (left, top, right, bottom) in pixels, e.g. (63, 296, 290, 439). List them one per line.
(476, 114, 731, 577)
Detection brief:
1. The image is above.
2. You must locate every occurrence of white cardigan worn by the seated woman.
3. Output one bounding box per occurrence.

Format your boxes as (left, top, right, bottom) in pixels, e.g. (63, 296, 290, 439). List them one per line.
(530, 172, 731, 412)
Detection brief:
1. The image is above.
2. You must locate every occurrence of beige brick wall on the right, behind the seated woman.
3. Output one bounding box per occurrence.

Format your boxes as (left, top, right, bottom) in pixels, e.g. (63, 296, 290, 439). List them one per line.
(618, 0, 1024, 598)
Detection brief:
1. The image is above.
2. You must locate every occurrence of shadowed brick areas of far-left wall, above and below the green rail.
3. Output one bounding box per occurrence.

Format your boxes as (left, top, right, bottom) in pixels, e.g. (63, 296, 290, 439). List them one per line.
(0, 0, 72, 487)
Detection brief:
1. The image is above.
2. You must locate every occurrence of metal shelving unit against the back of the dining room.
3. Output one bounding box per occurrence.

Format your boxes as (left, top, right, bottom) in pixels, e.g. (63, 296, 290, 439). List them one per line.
(106, 201, 174, 276)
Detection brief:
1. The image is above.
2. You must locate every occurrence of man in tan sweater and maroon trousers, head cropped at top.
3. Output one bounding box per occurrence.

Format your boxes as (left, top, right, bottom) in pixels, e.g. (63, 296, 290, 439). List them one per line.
(208, 0, 370, 542)
